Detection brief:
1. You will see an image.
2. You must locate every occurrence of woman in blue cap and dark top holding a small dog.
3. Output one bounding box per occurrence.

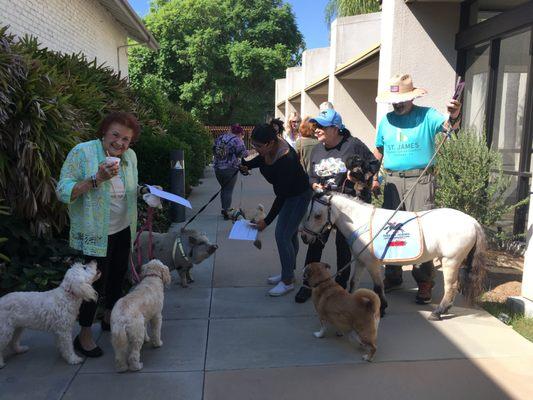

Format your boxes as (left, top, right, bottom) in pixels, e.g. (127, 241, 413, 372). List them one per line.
(295, 109, 379, 303)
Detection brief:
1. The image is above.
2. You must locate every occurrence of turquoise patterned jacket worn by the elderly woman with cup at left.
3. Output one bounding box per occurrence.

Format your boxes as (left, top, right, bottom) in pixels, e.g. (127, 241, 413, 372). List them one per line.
(56, 139, 138, 257)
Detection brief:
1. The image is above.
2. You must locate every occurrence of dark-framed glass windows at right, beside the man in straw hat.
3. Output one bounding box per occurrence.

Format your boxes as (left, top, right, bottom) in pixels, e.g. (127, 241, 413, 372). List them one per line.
(456, 0, 533, 235)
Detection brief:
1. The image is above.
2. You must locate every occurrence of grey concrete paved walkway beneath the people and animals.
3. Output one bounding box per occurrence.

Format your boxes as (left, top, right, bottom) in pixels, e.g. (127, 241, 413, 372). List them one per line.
(0, 167, 533, 400)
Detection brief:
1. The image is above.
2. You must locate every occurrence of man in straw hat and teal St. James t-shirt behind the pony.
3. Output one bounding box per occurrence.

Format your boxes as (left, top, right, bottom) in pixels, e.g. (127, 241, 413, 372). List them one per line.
(372, 75, 461, 304)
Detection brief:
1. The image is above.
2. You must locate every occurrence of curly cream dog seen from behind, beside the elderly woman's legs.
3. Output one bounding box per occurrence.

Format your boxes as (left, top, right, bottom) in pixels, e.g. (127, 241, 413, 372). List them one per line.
(111, 260, 170, 372)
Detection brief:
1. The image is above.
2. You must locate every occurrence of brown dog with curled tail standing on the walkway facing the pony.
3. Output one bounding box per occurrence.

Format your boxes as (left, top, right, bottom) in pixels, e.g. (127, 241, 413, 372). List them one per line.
(304, 262, 380, 361)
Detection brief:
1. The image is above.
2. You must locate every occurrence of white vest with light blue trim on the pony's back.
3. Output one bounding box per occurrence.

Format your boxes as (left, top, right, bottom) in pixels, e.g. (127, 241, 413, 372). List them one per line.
(370, 209, 423, 263)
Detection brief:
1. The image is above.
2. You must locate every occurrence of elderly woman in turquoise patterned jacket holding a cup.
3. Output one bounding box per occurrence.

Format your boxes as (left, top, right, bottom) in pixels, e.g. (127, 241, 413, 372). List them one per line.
(57, 112, 154, 357)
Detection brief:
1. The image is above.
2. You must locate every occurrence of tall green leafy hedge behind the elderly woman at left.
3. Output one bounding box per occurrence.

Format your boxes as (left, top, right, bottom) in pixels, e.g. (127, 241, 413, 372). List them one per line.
(0, 27, 210, 291)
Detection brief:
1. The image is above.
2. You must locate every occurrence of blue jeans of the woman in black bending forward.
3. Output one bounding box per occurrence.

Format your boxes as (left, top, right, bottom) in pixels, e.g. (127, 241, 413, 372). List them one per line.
(275, 190, 312, 282)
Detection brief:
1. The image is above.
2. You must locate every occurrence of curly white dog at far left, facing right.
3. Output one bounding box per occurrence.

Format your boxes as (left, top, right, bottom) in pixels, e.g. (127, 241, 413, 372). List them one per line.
(0, 261, 100, 368)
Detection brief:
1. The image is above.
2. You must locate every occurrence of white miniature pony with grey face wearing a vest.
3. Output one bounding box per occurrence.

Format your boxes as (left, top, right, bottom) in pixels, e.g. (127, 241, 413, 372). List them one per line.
(300, 192, 485, 320)
